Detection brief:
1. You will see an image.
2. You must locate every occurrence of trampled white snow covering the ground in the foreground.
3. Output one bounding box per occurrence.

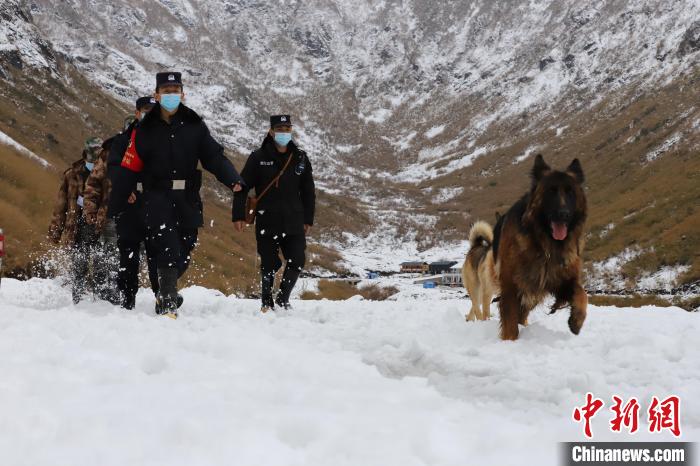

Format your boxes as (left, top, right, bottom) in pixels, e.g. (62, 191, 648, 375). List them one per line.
(0, 279, 700, 466)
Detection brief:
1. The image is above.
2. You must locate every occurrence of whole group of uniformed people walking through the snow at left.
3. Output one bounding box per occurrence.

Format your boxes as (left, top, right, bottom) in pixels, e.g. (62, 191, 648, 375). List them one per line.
(49, 72, 316, 318)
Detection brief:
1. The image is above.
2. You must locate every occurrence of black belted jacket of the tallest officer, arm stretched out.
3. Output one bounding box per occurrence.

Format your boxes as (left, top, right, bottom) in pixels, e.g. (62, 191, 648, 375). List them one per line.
(125, 104, 243, 229)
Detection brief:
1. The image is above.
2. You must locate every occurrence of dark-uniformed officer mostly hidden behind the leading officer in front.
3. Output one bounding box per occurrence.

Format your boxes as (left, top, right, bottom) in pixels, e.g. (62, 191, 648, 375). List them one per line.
(107, 96, 158, 309)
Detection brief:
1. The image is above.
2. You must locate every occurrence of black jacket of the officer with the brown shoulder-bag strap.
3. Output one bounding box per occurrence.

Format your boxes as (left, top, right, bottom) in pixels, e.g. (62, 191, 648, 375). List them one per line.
(233, 134, 316, 235)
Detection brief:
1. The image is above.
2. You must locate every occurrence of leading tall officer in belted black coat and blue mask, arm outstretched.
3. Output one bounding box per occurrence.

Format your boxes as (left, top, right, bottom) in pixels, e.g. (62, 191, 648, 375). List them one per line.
(116, 72, 243, 318)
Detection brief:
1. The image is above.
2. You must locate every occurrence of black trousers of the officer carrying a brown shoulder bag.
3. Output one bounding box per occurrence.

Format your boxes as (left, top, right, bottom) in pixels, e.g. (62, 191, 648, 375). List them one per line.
(256, 232, 306, 307)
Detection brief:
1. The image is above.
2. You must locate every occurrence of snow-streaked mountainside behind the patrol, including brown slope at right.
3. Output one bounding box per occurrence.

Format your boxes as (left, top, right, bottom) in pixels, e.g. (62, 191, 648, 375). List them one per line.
(0, 0, 700, 292)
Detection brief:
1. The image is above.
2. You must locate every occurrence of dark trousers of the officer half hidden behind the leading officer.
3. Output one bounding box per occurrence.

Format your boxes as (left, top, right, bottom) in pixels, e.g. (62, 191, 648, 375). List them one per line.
(117, 238, 158, 297)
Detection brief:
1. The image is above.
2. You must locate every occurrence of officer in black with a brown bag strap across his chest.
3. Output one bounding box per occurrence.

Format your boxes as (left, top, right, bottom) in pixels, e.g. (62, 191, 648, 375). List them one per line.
(233, 115, 316, 312)
